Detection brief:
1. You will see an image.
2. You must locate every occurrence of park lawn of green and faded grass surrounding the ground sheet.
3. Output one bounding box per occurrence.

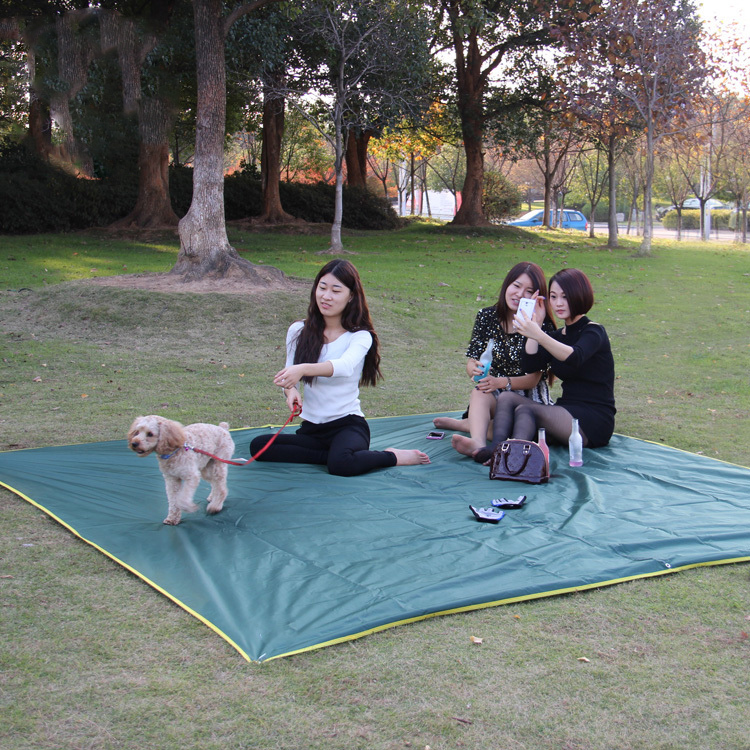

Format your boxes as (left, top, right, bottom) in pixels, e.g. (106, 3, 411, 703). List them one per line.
(0, 225, 750, 750)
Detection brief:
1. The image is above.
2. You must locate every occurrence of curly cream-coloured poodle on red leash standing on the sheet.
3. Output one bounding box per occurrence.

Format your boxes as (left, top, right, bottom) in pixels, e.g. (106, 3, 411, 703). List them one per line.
(128, 414, 234, 526)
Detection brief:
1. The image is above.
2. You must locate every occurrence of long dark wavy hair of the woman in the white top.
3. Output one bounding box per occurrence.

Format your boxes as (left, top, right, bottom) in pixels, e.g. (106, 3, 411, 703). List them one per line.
(294, 258, 383, 385)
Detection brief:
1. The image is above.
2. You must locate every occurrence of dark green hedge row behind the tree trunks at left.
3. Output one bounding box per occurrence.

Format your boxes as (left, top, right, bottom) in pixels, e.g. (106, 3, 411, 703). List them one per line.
(0, 145, 399, 234)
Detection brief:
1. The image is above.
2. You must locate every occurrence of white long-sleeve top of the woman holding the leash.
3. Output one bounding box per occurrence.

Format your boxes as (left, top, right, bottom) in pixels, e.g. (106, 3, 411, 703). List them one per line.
(286, 321, 372, 424)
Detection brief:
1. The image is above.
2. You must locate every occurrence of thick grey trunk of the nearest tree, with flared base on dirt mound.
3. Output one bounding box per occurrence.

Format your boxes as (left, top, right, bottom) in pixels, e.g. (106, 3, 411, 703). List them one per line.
(170, 0, 284, 286)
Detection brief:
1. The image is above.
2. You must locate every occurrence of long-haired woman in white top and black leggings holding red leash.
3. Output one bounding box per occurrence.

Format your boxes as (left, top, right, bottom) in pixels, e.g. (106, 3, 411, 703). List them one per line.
(250, 259, 430, 476)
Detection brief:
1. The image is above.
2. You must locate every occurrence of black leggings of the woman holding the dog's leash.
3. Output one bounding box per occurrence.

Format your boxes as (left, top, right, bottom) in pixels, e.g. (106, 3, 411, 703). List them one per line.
(250, 414, 396, 477)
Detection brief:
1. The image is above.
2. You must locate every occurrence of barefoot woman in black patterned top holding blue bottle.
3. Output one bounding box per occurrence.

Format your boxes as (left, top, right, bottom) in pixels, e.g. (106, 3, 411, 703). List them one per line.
(435, 263, 554, 461)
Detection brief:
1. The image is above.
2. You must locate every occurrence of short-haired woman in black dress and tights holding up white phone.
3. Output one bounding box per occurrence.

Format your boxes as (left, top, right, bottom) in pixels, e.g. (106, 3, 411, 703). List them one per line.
(494, 268, 616, 448)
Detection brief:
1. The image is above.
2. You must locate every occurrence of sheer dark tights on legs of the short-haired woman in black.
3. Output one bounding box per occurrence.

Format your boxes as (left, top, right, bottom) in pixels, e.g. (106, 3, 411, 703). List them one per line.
(492, 392, 588, 448)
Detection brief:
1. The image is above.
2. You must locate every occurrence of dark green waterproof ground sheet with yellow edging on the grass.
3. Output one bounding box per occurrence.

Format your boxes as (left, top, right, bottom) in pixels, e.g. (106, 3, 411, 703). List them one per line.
(0, 415, 750, 661)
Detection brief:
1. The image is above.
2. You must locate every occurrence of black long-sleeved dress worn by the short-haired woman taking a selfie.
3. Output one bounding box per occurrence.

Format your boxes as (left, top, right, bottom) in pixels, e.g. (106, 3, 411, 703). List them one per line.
(522, 315, 617, 448)
